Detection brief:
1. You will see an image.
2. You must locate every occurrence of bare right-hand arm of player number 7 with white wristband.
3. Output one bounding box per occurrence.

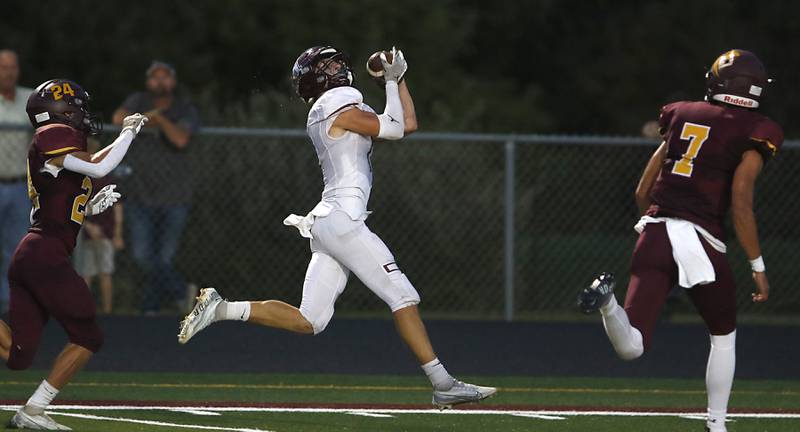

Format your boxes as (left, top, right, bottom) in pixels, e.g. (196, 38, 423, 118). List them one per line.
(731, 150, 769, 302)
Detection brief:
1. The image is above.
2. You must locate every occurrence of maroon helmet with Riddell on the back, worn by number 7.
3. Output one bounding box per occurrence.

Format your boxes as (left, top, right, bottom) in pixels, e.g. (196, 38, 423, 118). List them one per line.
(706, 49, 772, 109)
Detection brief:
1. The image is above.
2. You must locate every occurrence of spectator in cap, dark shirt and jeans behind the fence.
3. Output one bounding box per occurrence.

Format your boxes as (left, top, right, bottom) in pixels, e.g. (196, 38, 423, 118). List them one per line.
(113, 61, 200, 315)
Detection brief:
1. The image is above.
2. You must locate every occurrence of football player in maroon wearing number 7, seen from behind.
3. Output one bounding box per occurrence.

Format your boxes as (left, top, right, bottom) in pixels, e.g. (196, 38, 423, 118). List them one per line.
(579, 50, 783, 432)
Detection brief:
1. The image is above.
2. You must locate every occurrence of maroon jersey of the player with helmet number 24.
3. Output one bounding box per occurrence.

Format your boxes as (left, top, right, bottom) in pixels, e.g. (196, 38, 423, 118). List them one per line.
(28, 125, 92, 253)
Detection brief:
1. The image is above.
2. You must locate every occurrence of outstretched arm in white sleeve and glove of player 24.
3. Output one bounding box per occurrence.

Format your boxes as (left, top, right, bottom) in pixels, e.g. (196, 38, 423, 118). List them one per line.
(48, 114, 147, 178)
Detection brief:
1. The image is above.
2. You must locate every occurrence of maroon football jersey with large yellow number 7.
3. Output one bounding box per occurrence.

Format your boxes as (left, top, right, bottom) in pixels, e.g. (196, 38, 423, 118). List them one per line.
(647, 102, 783, 240)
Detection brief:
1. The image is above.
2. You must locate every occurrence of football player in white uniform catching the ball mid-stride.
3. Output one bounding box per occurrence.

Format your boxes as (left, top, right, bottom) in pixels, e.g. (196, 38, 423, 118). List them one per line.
(178, 46, 497, 408)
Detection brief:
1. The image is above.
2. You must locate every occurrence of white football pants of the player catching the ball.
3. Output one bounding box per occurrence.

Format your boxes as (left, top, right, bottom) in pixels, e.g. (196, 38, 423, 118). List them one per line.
(300, 210, 420, 334)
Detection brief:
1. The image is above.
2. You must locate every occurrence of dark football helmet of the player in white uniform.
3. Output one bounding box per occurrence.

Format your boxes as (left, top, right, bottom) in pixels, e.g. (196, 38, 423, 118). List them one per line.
(292, 46, 353, 103)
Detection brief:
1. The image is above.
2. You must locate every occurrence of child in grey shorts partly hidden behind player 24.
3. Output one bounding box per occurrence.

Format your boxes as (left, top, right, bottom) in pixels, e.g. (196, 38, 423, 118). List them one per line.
(76, 138, 124, 314)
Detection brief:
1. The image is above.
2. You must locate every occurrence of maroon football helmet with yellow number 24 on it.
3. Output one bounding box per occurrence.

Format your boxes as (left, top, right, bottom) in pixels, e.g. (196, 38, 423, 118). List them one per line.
(25, 79, 103, 135)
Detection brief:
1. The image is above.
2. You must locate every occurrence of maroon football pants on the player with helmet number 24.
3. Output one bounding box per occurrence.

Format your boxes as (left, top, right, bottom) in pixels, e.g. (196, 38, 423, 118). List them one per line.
(8, 233, 103, 369)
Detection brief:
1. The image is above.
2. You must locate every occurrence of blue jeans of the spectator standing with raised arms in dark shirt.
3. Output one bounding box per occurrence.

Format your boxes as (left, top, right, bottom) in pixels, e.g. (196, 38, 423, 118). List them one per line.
(125, 201, 189, 313)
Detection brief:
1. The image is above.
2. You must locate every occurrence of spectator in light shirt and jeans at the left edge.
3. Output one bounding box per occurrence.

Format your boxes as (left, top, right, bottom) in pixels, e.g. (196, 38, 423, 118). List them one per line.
(0, 50, 33, 313)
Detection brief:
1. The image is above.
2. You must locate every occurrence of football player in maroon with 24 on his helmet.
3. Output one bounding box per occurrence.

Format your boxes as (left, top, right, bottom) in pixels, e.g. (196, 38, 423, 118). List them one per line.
(0, 79, 147, 430)
